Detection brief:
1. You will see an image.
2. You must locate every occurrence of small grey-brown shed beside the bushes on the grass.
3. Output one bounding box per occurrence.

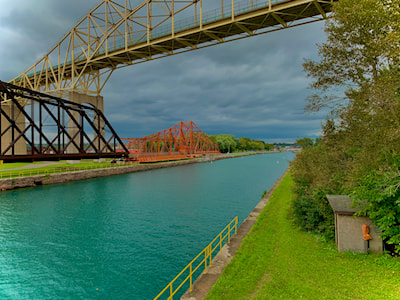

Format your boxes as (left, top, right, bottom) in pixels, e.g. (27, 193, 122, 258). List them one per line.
(326, 195, 383, 253)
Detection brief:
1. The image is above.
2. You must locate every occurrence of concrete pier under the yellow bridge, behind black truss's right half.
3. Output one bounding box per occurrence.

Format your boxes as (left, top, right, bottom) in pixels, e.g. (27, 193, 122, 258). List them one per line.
(67, 92, 105, 154)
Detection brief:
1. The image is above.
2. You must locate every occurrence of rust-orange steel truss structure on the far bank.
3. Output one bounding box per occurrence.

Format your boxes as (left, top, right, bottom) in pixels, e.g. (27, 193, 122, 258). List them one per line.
(121, 121, 220, 163)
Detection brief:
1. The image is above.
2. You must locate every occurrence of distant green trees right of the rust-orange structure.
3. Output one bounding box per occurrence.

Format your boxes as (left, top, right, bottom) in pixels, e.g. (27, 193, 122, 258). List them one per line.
(210, 134, 275, 153)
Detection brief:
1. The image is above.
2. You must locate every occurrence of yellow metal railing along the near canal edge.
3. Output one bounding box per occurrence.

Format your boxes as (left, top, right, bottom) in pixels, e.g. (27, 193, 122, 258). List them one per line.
(154, 217, 238, 300)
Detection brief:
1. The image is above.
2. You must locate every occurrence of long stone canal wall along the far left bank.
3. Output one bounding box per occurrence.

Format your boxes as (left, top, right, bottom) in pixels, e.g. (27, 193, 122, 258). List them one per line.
(0, 152, 275, 192)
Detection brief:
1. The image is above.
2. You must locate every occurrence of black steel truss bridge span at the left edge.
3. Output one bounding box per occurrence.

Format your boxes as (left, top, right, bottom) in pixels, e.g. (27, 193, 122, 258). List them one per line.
(0, 81, 129, 161)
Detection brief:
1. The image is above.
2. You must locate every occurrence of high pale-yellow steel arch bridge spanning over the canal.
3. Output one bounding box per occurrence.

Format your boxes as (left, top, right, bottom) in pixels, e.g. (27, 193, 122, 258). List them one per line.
(10, 0, 337, 98)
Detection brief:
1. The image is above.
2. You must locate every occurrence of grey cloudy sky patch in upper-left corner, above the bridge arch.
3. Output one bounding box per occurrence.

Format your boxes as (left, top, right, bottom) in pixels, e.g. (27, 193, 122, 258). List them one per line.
(0, 0, 97, 81)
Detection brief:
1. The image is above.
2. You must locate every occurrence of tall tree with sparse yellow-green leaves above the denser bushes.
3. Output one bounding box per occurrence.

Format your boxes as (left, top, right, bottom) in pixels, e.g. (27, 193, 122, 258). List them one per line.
(303, 0, 400, 115)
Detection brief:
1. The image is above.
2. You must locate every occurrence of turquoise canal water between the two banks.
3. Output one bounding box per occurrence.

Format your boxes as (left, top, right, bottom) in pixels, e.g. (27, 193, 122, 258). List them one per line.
(0, 152, 294, 299)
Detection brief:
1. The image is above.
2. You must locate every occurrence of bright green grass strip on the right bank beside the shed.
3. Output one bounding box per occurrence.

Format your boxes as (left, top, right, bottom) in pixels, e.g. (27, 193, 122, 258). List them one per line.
(206, 175, 400, 300)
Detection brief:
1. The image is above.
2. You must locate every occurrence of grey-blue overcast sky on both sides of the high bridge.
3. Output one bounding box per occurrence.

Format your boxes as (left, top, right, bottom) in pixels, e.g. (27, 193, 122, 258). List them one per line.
(0, 0, 332, 142)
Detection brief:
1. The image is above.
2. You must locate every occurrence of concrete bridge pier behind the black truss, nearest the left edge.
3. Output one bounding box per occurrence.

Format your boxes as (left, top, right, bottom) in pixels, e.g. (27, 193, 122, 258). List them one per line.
(0, 102, 27, 155)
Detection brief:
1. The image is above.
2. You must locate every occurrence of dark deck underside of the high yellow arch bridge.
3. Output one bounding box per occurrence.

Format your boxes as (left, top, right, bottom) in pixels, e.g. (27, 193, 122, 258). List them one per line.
(25, 0, 332, 85)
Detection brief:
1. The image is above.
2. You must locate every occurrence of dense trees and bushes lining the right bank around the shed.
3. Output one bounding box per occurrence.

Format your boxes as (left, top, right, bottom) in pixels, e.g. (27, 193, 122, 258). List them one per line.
(292, 0, 400, 253)
